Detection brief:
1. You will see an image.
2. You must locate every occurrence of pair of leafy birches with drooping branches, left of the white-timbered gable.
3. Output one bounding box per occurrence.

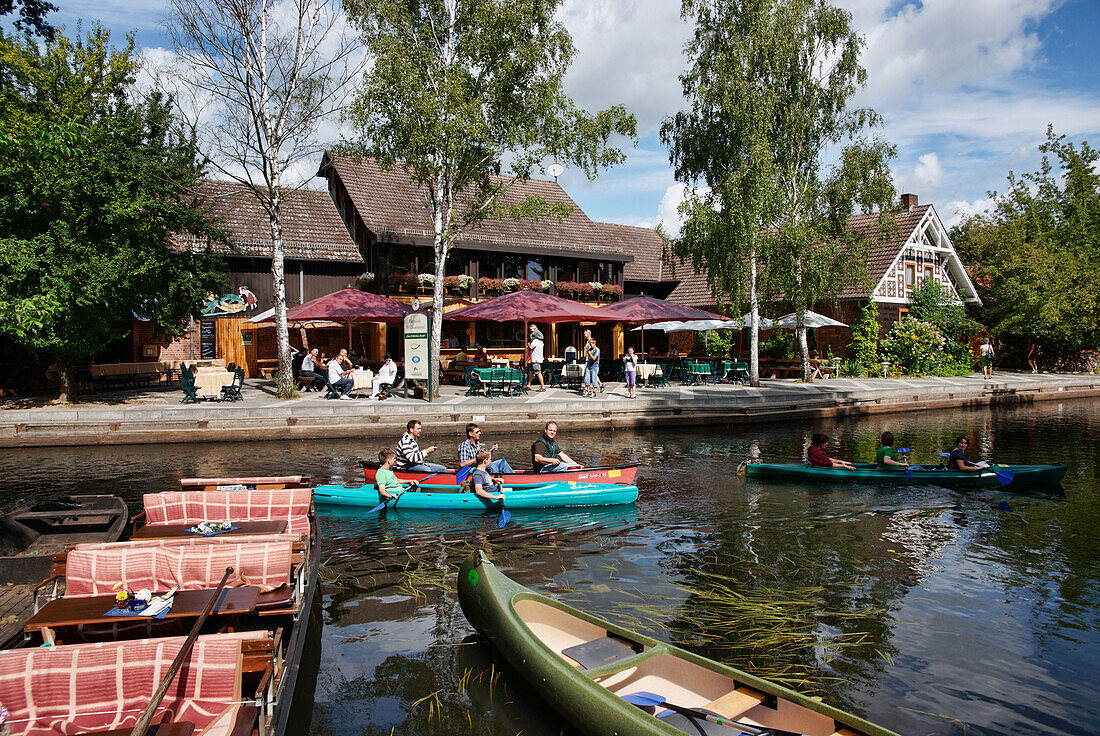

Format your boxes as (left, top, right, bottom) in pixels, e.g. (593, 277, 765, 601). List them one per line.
(661, 0, 894, 384)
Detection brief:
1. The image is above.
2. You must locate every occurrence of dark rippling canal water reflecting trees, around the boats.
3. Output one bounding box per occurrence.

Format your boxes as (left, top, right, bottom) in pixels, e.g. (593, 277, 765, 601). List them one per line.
(0, 400, 1100, 736)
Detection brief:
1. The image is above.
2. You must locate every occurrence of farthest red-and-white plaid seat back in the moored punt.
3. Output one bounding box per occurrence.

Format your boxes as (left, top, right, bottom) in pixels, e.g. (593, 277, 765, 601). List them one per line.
(144, 488, 314, 534)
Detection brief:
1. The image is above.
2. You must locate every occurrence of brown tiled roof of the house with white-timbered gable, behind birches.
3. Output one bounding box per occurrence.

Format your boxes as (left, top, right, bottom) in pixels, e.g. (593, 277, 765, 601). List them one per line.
(669, 205, 931, 307)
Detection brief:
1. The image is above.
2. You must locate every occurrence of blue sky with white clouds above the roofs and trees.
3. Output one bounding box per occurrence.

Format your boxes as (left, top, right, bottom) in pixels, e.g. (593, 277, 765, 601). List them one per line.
(15, 0, 1100, 233)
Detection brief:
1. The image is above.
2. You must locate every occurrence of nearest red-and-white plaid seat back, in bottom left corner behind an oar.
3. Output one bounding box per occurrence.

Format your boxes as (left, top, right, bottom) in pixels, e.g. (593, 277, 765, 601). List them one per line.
(0, 631, 261, 736)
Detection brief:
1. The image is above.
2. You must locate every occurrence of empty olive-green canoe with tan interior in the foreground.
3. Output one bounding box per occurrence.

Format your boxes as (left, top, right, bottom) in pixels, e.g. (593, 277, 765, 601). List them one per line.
(459, 550, 893, 736)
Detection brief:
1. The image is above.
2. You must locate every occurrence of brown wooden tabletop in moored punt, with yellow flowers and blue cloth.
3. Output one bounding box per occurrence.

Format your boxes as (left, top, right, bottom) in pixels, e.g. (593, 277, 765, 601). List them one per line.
(23, 585, 260, 644)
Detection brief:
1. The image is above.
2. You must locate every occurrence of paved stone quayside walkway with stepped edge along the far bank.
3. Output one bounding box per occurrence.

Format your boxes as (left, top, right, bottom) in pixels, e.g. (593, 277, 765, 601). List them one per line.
(0, 373, 1100, 447)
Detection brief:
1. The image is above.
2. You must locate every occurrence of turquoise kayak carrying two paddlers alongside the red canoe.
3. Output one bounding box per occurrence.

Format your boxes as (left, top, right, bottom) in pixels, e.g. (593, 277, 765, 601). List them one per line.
(314, 481, 638, 512)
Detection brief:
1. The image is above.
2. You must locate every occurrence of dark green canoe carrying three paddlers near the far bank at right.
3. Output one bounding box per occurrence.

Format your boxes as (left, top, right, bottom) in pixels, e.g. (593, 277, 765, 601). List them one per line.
(745, 462, 1066, 491)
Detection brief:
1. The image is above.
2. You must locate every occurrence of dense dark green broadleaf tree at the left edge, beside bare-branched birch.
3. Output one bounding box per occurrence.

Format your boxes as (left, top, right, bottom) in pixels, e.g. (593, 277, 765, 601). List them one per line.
(0, 28, 219, 398)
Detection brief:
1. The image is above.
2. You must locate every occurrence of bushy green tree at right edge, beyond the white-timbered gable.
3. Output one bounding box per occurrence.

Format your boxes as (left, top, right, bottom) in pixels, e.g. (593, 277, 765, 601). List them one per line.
(952, 127, 1100, 353)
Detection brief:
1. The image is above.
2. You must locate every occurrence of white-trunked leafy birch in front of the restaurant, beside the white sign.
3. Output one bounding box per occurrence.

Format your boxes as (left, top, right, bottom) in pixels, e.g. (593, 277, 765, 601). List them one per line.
(344, 0, 636, 396)
